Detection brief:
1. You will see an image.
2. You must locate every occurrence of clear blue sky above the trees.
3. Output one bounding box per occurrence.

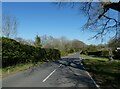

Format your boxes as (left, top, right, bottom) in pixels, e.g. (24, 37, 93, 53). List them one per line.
(2, 2, 118, 45)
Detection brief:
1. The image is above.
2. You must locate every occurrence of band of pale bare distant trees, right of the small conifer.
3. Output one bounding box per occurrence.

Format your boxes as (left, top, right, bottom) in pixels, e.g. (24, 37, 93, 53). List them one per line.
(42, 35, 86, 52)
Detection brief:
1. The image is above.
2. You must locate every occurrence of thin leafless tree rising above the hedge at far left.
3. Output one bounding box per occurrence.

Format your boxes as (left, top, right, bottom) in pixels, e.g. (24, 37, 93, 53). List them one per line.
(2, 15, 18, 38)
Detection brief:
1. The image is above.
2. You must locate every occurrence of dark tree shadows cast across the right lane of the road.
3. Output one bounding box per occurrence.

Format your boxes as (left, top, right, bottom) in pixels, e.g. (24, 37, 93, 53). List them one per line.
(55, 58, 97, 89)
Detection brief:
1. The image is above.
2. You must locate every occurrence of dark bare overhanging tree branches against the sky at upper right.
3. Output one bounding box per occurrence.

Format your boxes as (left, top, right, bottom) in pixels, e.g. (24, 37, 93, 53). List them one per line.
(56, 0, 120, 38)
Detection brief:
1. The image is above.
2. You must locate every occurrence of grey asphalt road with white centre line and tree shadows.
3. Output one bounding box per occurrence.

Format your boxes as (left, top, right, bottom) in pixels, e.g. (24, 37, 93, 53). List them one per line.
(2, 53, 97, 89)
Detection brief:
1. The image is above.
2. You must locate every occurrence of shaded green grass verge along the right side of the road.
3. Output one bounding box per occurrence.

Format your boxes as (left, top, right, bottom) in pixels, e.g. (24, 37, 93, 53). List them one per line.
(81, 55, 120, 89)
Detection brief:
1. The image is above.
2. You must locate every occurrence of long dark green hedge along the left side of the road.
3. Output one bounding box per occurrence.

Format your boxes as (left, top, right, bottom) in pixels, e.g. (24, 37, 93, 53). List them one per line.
(2, 37, 60, 67)
